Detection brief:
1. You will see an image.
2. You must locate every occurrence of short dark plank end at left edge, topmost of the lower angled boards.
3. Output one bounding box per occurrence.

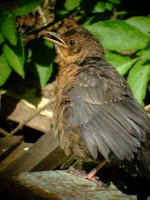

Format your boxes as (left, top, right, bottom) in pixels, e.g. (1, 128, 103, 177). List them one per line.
(0, 136, 23, 160)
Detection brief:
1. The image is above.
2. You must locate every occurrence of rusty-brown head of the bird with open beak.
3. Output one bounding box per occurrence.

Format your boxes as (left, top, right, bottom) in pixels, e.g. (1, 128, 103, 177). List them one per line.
(44, 28, 104, 65)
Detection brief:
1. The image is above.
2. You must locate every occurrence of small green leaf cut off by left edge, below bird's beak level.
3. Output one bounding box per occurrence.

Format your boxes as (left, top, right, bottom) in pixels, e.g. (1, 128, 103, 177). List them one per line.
(0, 55, 11, 86)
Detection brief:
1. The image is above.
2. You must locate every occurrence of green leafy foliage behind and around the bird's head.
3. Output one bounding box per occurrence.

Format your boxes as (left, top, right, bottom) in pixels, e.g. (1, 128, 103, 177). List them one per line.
(0, 0, 150, 104)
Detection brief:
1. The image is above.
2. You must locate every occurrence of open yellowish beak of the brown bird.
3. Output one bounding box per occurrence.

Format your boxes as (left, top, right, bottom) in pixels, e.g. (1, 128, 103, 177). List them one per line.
(44, 31, 67, 47)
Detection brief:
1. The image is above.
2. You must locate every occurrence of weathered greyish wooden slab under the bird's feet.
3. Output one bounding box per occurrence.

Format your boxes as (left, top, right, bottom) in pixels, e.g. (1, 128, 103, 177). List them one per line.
(1, 170, 136, 200)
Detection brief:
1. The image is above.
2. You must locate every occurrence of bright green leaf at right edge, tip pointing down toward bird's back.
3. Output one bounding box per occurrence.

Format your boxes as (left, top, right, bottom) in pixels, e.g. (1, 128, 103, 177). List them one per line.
(128, 60, 150, 105)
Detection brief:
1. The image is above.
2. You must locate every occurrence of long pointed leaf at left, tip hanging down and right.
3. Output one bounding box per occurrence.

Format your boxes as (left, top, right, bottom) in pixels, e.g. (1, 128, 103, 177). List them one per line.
(3, 40, 25, 78)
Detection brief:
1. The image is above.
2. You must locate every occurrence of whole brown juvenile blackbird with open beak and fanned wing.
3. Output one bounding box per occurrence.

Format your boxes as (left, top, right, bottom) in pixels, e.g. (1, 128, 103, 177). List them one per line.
(45, 28, 150, 179)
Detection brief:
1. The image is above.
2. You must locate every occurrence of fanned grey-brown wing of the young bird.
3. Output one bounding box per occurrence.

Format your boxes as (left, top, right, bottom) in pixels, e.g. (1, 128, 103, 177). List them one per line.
(68, 66, 150, 160)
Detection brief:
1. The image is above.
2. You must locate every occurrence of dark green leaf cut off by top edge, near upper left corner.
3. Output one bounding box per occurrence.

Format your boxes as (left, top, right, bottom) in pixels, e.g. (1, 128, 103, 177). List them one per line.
(15, 0, 43, 16)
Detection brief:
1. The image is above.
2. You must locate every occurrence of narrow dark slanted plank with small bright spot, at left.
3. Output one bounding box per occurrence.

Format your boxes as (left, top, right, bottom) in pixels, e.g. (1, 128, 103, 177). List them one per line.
(0, 142, 33, 171)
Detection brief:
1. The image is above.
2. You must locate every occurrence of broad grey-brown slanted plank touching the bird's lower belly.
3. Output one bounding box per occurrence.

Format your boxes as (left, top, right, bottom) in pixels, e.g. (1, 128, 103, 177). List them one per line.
(0, 133, 67, 179)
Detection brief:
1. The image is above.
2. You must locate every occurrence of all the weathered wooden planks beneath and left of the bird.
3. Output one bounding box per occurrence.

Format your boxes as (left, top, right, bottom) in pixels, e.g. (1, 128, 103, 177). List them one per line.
(0, 96, 150, 200)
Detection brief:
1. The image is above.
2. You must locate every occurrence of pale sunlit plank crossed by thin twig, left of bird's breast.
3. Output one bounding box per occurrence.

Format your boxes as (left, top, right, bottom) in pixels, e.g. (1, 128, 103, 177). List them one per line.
(1, 95, 51, 132)
